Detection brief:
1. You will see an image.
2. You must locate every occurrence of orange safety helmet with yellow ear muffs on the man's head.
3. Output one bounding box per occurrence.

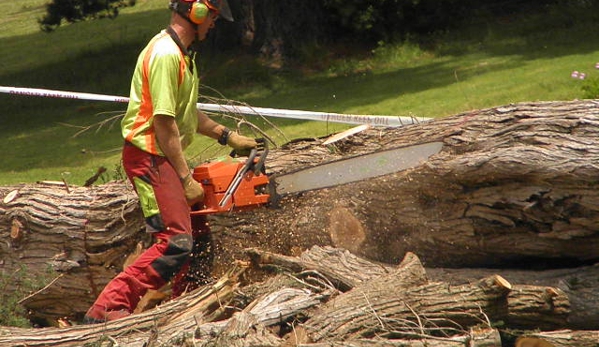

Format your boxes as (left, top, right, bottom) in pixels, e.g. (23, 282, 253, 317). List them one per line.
(169, 0, 233, 24)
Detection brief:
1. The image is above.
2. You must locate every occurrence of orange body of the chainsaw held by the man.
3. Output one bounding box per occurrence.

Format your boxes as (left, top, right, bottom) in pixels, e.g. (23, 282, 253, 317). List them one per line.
(191, 158, 270, 215)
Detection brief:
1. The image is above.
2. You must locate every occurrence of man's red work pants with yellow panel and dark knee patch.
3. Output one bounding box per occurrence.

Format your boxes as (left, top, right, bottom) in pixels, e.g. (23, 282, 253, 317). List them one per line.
(86, 143, 193, 321)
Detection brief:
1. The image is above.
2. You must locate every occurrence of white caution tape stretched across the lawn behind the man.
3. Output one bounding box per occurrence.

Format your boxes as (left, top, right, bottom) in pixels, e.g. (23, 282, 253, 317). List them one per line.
(0, 86, 431, 127)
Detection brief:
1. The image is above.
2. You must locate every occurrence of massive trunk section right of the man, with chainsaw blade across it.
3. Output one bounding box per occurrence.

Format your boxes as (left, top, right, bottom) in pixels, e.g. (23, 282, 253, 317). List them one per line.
(213, 101, 599, 267)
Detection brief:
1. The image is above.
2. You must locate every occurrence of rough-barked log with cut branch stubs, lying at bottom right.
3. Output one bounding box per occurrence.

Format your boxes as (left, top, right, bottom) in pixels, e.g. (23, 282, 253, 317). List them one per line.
(306, 274, 569, 342)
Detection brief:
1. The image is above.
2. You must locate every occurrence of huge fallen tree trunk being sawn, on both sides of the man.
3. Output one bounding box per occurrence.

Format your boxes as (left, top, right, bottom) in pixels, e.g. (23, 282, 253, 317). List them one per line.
(0, 101, 599, 326)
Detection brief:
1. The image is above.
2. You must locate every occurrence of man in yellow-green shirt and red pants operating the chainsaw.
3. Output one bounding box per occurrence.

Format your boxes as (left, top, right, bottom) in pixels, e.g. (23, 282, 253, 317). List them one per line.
(84, 0, 257, 323)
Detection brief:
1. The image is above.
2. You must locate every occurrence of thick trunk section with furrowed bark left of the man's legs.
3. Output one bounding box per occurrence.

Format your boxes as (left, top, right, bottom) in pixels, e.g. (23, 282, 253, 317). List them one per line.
(0, 182, 145, 319)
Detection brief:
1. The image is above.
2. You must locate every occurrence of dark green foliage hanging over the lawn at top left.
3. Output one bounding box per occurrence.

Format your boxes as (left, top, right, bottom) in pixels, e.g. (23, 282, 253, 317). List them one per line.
(39, 0, 135, 31)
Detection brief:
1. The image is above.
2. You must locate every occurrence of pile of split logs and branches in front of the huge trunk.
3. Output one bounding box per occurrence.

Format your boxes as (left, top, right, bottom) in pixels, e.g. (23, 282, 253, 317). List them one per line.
(0, 247, 584, 347)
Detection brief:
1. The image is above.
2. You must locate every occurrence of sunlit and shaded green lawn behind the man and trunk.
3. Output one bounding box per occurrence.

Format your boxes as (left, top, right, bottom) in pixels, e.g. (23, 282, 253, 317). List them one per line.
(0, 0, 599, 185)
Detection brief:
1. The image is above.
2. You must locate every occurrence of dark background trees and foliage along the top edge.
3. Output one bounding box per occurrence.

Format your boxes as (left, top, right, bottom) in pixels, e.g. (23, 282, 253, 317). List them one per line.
(40, 0, 599, 59)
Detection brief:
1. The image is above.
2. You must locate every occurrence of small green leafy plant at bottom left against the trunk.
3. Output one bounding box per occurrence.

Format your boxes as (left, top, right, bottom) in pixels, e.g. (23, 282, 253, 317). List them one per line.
(0, 266, 47, 328)
